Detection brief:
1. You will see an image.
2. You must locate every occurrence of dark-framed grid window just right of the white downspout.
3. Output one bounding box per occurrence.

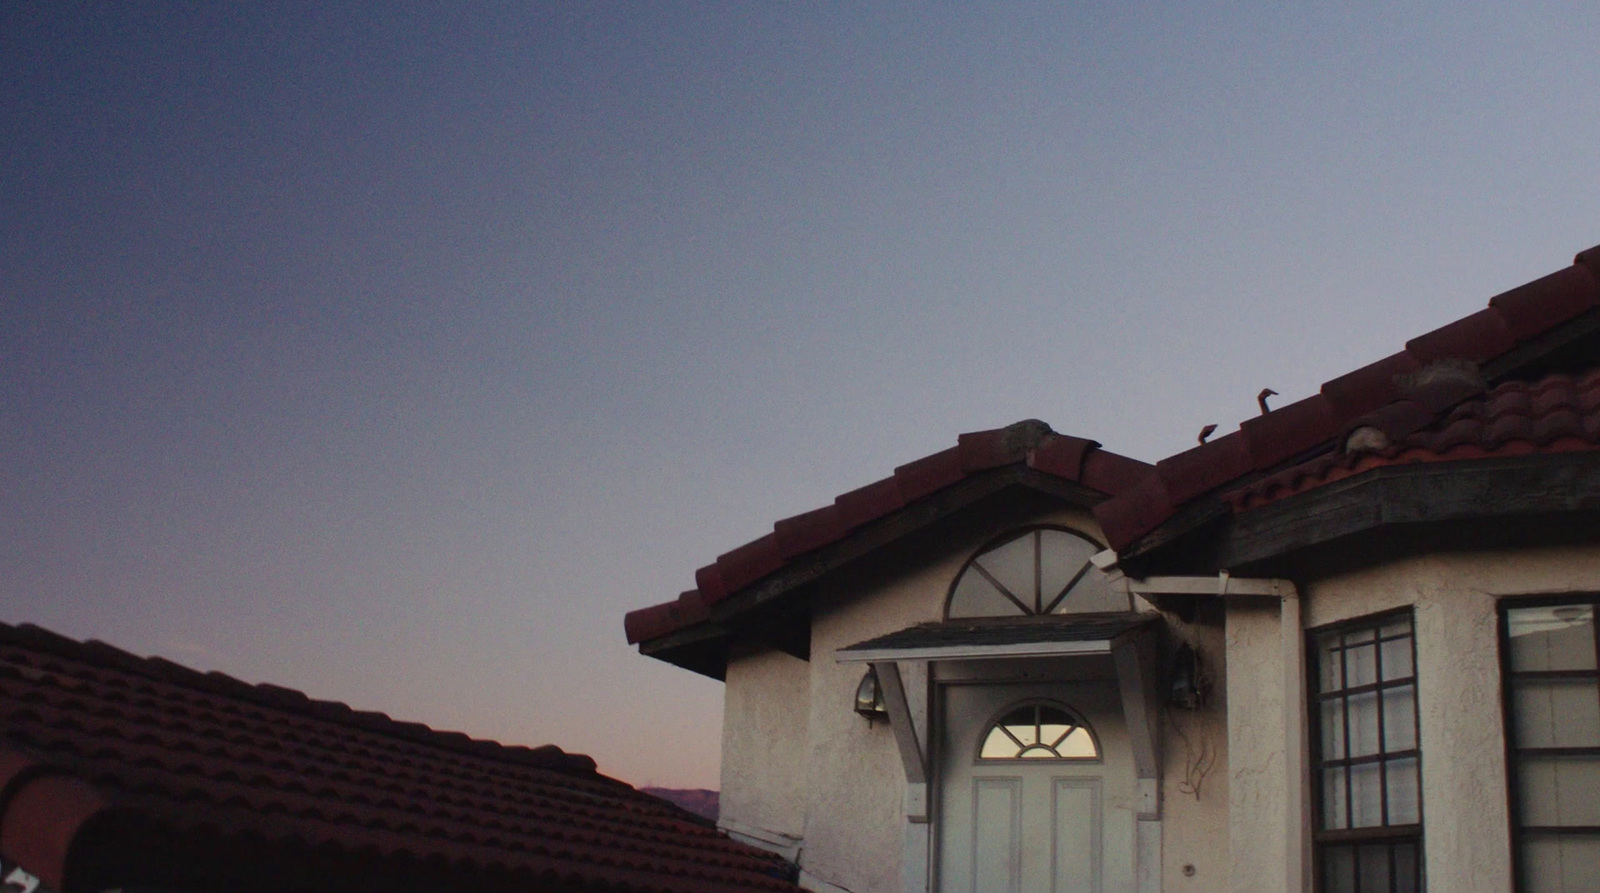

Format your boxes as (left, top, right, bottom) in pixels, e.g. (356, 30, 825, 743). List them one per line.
(1312, 615, 1422, 893)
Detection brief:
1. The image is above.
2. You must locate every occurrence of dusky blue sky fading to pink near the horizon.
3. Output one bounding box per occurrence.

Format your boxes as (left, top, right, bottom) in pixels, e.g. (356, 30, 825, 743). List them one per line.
(0, 0, 1600, 787)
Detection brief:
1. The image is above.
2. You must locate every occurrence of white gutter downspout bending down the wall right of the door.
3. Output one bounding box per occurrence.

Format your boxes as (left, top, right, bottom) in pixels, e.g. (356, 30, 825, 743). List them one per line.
(1094, 551, 1310, 893)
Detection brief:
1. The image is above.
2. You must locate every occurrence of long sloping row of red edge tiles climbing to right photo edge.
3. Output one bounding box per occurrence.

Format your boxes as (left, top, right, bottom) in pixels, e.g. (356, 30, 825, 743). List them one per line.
(1094, 246, 1600, 551)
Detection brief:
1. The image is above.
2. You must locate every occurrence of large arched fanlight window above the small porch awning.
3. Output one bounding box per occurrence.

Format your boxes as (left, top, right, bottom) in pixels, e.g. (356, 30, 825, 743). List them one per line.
(944, 527, 1133, 618)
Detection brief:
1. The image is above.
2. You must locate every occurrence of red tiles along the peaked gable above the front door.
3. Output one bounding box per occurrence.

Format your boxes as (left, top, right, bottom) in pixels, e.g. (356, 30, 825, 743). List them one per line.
(624, 419, 1150, 643)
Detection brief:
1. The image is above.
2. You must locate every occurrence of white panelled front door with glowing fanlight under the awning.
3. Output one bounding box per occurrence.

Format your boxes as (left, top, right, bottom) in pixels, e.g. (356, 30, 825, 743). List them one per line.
(938, 682, 1134, 893)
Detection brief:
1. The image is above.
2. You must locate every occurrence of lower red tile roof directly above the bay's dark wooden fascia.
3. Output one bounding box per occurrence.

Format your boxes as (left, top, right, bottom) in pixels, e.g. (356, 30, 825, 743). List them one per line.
(1224, 368, 1600, 512)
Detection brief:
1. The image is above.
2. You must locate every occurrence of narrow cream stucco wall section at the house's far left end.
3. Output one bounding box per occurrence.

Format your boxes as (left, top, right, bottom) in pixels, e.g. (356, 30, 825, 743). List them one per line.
(720, 651, 811, 839)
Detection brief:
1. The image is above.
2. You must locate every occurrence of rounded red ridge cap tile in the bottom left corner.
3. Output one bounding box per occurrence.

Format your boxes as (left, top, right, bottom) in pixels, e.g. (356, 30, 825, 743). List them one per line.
(0, 775, 109, 890)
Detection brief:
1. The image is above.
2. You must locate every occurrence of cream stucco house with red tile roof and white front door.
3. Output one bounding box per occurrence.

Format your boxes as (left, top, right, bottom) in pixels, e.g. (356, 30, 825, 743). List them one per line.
(626, 248, 1600, 893)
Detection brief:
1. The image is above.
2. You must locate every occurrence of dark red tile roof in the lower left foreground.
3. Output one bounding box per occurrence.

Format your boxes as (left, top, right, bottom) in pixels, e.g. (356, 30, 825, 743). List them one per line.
(0, 624, 797, 893)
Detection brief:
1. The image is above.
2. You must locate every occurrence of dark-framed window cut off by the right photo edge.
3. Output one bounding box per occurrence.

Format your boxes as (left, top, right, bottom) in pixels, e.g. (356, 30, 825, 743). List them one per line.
(1502, 599, 1600, 893)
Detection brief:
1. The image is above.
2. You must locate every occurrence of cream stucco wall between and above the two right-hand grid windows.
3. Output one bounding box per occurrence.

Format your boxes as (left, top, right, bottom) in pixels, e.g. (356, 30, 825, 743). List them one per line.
(1306, 547, 1600, 891)
